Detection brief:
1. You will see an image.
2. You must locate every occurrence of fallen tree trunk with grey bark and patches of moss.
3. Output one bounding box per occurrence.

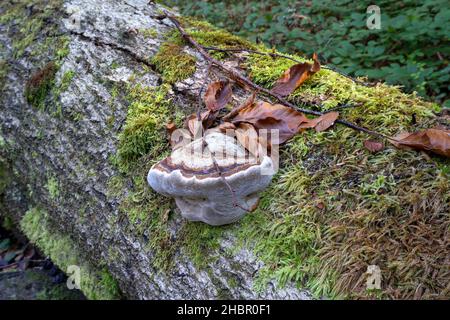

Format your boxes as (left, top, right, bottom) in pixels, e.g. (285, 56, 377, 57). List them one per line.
(0, 0, 449, 299)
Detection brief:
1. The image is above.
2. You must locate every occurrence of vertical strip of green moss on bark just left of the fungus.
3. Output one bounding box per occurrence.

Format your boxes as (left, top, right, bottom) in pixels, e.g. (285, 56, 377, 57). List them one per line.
(108, 85, 183, 268)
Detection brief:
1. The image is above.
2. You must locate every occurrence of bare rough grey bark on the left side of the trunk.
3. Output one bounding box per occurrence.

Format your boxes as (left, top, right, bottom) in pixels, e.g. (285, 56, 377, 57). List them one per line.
(0, 0, 308, 299)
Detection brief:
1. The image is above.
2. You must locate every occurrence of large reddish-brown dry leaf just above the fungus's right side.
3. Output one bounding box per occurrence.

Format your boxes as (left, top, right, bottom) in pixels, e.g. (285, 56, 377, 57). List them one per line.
(232, 101, 308, 143)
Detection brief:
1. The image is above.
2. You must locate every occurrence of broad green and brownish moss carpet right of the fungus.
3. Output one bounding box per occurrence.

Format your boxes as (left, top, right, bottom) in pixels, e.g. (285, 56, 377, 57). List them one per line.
(230, 47, 450, 298)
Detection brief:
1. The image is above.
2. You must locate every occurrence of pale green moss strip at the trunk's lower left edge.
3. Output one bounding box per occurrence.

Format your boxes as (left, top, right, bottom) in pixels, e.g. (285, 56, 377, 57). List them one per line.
(20, 208, 120, 300)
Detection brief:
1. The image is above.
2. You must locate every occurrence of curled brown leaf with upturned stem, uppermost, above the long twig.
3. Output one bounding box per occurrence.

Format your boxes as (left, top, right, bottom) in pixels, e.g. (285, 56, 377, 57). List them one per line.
(272, 53, 320, 97)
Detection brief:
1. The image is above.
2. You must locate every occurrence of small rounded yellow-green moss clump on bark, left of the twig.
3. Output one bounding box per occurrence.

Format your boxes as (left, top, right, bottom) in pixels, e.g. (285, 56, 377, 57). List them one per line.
(152, 42, 195, 83)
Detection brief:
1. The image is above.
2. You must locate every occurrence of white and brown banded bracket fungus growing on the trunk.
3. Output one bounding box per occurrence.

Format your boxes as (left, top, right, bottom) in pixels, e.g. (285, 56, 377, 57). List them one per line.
(147, 131, 274, 226)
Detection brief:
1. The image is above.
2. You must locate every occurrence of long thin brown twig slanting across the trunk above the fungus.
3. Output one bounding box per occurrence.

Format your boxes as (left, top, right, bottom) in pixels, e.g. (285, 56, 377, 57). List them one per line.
(165, 12, 389, 139)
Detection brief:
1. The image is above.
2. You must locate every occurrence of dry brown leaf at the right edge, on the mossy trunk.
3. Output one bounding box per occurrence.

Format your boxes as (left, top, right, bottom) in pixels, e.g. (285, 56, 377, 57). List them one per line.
(389, 129, 450, 158)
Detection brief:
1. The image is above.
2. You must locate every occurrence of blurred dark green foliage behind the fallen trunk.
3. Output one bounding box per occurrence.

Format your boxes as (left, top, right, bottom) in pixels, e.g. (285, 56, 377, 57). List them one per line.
(160, 0, 450, 107)
